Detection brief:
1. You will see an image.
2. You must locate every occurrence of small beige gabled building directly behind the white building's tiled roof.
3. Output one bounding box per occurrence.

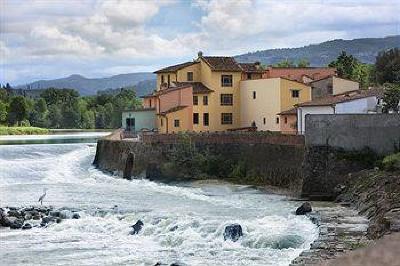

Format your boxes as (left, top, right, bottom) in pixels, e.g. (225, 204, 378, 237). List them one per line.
(310, 75, 360, 100)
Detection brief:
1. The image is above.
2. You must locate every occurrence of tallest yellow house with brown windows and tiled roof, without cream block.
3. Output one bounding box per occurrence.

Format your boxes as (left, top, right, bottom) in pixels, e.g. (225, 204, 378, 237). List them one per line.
(145, 53, 263, 133)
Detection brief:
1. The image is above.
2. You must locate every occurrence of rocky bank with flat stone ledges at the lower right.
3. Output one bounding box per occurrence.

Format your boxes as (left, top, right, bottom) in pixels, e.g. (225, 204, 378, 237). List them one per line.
(291, 169, 400, 266)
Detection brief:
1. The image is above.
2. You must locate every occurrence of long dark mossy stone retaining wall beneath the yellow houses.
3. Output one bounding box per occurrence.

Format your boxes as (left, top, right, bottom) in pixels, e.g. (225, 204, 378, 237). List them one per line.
(94, 135, 304, 190)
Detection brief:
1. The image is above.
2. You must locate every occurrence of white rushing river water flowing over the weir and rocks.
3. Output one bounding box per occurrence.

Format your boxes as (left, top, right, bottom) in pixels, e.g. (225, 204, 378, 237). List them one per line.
(0, 133, 318, 266)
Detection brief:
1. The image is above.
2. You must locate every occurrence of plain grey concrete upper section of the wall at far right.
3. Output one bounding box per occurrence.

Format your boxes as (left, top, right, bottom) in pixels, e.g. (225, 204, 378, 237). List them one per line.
(305, 114, 400, 154)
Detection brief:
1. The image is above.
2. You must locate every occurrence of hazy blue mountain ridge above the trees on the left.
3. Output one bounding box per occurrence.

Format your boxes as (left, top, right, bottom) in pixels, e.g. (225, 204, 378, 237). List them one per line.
(15, 72, 156, 96)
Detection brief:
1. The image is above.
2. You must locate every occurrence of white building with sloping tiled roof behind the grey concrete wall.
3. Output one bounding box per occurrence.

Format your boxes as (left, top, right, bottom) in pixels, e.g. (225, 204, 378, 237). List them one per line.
(297, 89, 383, 134)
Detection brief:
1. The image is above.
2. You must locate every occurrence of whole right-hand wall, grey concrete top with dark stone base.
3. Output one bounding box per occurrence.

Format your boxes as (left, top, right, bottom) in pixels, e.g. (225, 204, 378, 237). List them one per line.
(302, 114, 400, 200)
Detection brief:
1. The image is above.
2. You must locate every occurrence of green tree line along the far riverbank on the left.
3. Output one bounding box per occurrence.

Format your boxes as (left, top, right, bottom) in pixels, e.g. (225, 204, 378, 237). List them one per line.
(0, 87, 140, 129)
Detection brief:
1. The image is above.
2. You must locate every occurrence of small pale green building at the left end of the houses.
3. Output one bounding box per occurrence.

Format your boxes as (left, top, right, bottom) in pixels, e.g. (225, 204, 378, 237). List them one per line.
(122, 108, 157, 132)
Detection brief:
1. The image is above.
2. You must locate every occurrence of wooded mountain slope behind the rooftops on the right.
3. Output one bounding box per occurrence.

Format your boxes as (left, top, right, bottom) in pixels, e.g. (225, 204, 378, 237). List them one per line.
(235, 35, 400, 66)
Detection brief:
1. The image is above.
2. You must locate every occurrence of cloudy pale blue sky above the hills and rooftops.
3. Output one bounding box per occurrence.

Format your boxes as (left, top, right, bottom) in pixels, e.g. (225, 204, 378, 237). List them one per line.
(0, 0, 400, 85)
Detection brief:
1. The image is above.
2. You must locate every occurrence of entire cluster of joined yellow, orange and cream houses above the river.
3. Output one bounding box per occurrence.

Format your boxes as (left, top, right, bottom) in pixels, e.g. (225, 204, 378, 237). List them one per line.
(144, 52, 311, 133)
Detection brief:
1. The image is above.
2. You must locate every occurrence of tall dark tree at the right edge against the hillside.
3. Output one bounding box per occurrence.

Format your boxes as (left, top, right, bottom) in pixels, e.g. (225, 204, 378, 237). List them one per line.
(375, 48, 400, 84)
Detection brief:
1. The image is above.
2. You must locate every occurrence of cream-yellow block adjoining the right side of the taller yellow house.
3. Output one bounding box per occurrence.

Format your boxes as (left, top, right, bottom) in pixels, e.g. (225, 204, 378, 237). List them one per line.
(240, 78, 311, 131)
